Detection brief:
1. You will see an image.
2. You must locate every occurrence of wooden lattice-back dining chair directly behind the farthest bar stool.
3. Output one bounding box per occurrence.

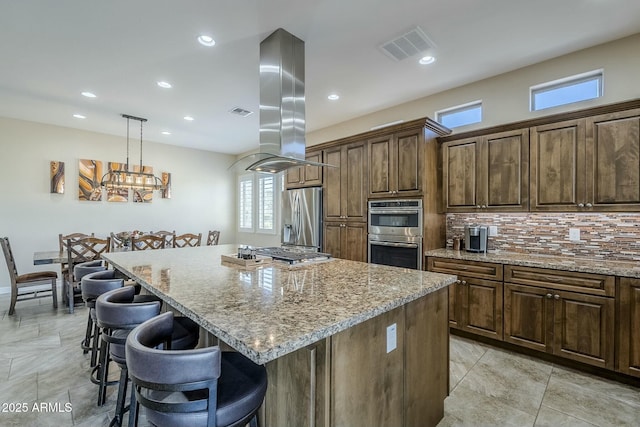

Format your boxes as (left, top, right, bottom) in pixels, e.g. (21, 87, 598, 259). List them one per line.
(62, 237, 111, 313)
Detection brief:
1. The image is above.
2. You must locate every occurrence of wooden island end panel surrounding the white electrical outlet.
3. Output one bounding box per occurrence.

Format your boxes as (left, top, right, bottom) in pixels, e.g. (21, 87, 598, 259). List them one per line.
(331, 306, 405, 427)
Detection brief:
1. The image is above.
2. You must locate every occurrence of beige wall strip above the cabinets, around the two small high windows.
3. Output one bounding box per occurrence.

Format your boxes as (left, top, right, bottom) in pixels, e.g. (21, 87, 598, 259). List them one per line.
(307, 34, 640, 146)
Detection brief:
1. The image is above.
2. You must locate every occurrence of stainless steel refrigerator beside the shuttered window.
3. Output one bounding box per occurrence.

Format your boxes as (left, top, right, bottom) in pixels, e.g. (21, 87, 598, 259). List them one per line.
(281, 187, 322, 251)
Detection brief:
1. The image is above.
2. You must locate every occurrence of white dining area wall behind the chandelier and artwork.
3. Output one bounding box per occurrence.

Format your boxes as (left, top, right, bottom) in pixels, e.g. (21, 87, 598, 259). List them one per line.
(0, 118, 236, 291)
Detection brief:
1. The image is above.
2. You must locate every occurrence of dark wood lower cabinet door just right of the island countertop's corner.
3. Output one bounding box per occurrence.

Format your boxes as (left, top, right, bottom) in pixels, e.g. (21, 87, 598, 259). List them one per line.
(460, 277, 502, 340)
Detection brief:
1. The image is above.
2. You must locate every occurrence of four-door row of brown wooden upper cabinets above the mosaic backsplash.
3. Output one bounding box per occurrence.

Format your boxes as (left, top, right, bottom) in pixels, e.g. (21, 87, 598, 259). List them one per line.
(441, 100, 640, 212)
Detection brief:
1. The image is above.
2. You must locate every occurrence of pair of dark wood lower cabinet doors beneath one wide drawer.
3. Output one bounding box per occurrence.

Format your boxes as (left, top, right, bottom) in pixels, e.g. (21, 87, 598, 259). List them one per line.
(504, 283, 615, 369)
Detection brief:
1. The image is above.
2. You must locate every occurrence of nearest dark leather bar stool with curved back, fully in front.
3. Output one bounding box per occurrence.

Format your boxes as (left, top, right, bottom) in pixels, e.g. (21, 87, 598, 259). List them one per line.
(126, 312, 267, 427)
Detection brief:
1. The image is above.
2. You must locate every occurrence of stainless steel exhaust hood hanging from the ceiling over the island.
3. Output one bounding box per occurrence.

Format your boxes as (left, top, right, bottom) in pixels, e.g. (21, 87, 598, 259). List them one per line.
(236, 28, 331, 173)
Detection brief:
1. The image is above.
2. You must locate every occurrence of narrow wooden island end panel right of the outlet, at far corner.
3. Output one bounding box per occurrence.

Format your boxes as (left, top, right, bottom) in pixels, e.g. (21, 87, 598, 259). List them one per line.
(404, 288, 449, 427)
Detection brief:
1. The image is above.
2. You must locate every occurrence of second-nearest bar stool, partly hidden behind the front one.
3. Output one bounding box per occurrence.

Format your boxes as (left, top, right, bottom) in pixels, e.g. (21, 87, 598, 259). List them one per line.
(96, 286, 200, 426)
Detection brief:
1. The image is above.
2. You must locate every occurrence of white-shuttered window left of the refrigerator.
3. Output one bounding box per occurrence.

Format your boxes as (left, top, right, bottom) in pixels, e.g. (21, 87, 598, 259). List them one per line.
(238, 173, 279, 233)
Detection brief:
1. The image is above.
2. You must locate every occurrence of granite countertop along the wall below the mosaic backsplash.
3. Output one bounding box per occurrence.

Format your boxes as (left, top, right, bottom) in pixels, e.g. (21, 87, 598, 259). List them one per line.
(425, 249, 640, 278)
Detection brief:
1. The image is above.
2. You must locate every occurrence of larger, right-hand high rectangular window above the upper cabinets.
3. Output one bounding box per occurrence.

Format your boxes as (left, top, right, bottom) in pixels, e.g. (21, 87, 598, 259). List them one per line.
(530, 70, 603, 111)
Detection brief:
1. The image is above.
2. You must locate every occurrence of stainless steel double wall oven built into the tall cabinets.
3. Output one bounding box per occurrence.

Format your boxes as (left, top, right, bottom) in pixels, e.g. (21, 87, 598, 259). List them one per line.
(368, 199, 422, 270)
